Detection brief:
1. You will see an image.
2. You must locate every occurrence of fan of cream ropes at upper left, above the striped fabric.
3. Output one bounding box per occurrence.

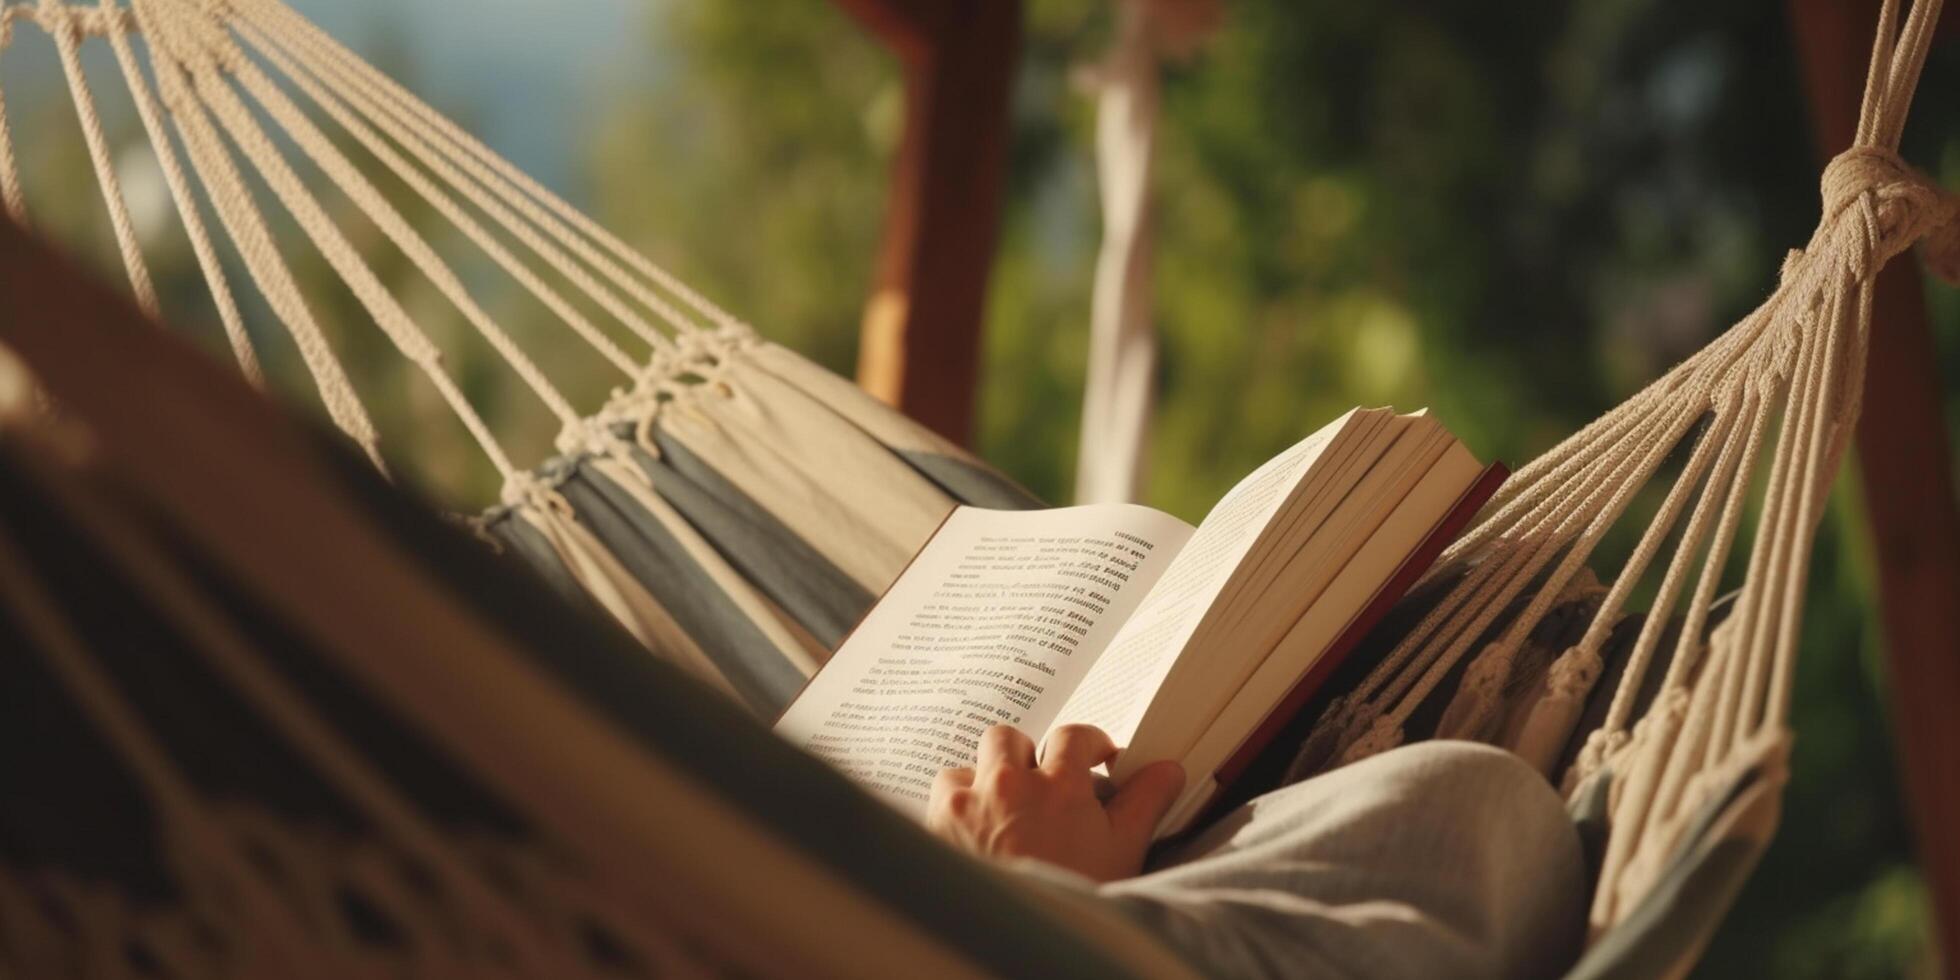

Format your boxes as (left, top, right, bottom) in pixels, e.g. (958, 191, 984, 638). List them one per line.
(0, 0, 772, 490)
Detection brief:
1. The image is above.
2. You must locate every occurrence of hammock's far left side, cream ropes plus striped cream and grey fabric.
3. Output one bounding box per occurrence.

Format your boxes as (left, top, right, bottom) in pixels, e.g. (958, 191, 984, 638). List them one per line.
(0, 0, 1039, 717)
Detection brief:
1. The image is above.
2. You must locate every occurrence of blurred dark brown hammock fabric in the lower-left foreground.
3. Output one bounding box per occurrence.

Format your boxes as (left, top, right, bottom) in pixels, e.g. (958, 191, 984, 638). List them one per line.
(0, 241, 1192, 978)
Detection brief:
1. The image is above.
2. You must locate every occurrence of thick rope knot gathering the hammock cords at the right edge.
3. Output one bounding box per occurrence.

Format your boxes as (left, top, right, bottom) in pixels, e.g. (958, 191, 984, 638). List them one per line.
(1821, 147, 1960, 282)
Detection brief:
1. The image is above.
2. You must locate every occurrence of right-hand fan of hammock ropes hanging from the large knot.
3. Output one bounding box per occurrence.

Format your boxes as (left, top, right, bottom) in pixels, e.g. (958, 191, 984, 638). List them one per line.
(1285, 2, 1960, 931)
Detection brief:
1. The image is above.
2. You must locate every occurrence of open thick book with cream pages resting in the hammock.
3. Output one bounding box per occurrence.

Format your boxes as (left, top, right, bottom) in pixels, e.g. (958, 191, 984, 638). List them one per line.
(776, 408, 1503, 835)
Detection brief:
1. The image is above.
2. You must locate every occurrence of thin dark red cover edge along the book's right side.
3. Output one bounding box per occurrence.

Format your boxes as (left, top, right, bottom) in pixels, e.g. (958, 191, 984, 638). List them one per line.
(1192, 463, 1511, 827)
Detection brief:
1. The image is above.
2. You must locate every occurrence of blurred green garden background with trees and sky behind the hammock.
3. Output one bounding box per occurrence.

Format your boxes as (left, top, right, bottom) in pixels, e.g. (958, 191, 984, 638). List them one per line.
(0, 0, 1960, 976)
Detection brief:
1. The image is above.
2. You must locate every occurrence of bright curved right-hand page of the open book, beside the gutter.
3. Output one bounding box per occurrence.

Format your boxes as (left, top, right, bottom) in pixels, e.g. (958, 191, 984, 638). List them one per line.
(1058, 412, 1354, 745)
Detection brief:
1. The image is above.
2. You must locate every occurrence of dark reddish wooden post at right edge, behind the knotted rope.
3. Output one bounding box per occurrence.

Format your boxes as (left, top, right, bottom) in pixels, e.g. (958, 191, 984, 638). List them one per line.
(1789, 0, 1960, 972)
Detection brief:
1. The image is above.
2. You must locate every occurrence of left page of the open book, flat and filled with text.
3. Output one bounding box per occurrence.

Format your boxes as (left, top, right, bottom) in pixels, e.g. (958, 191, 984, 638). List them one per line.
(776, 504, 1194, 815)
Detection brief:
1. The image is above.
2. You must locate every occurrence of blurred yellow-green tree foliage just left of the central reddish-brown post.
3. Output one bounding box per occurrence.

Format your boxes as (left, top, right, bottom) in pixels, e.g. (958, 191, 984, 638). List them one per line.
(592, 2, 904, 374)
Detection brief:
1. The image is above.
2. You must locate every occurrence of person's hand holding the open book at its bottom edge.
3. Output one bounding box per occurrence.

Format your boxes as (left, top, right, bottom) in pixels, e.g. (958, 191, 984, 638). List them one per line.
(925, 725, 1184, 882)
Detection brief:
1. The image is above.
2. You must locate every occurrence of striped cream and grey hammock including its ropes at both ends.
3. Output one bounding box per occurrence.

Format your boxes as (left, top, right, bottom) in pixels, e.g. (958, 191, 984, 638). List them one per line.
(0, 0, 1960, 976)
